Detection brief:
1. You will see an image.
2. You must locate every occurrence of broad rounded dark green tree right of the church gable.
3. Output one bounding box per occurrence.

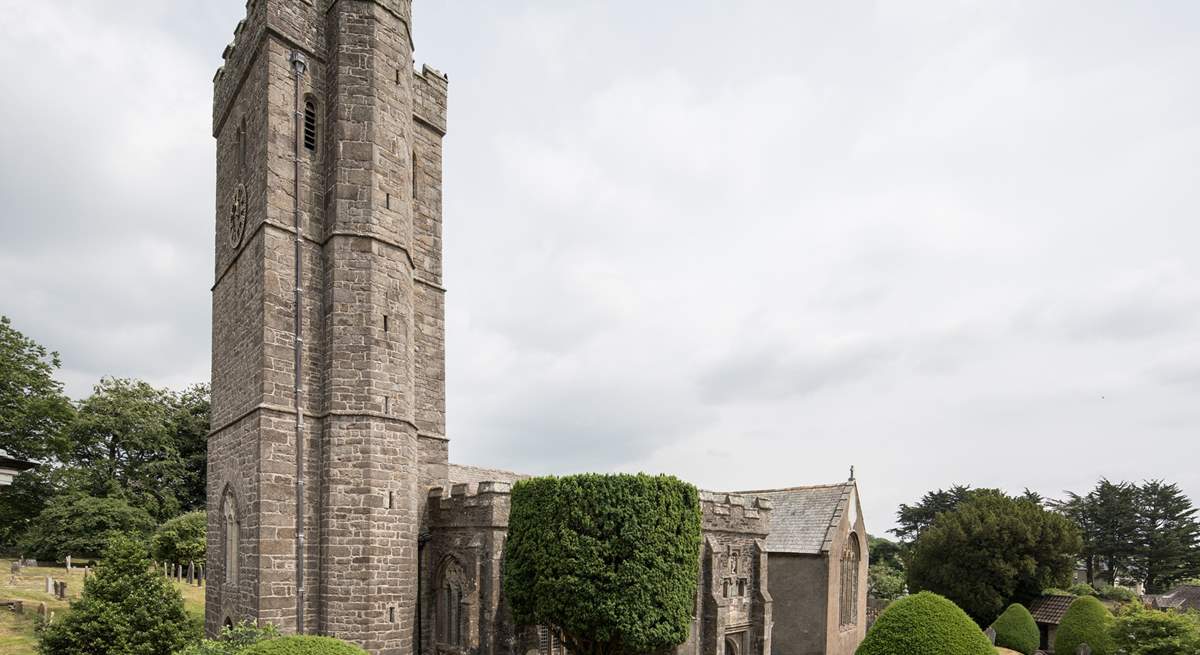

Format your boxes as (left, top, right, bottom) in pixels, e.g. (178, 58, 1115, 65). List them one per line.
(907, 493, 1080, 626)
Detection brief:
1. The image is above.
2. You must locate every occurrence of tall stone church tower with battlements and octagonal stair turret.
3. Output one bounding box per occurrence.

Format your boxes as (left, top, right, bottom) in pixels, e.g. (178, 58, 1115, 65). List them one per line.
(205, 0, 446, 654)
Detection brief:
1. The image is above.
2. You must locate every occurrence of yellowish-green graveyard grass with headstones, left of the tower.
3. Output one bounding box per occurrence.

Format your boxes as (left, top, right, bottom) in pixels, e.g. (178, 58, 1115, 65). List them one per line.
(0, 559, 204, 655)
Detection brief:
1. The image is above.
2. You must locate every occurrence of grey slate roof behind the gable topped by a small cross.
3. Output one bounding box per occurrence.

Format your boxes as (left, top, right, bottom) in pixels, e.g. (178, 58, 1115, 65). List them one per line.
(732, 481, 854, 555)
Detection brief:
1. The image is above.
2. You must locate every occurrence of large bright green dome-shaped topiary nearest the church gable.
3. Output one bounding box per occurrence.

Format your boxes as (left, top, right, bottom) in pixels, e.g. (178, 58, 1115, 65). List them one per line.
(854, 591, 996, 655)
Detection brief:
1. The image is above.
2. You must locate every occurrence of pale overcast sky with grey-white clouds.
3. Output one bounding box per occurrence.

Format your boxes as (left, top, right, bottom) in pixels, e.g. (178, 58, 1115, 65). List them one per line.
(0, 0, 1200, 533)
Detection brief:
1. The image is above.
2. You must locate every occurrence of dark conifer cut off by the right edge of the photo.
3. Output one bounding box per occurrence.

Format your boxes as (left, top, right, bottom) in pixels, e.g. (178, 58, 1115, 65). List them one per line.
(1130, 480, 1200, 594)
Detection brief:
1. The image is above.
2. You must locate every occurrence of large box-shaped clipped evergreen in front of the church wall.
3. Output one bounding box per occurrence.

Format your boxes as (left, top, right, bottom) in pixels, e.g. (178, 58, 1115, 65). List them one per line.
(504, 474, 701, 655)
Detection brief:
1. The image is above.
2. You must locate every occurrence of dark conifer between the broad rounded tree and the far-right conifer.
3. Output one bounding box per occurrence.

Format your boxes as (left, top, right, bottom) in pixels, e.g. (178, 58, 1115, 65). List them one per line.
(1055, 477, 1138, 584)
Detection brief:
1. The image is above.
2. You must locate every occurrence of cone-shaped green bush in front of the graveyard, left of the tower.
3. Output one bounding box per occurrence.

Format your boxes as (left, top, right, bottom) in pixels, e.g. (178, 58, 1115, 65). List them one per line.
(38, 536, 200, 655)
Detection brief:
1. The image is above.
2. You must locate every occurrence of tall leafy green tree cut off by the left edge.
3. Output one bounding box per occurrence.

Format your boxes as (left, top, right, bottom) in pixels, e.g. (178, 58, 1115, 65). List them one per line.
(0, 316, 71, 459)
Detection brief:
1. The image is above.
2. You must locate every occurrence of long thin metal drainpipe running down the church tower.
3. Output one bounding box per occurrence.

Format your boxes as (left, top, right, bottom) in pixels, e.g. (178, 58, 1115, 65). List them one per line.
(288, 50, 308, 635)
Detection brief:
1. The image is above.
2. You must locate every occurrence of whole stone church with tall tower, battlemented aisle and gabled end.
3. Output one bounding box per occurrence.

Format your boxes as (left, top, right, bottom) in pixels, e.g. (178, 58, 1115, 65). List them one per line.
(205, 0, 868, 655)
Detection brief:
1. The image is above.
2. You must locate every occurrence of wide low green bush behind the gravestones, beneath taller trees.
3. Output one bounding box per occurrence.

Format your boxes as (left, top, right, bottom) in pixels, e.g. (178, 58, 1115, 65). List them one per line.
(22, 495, 154, 561)
